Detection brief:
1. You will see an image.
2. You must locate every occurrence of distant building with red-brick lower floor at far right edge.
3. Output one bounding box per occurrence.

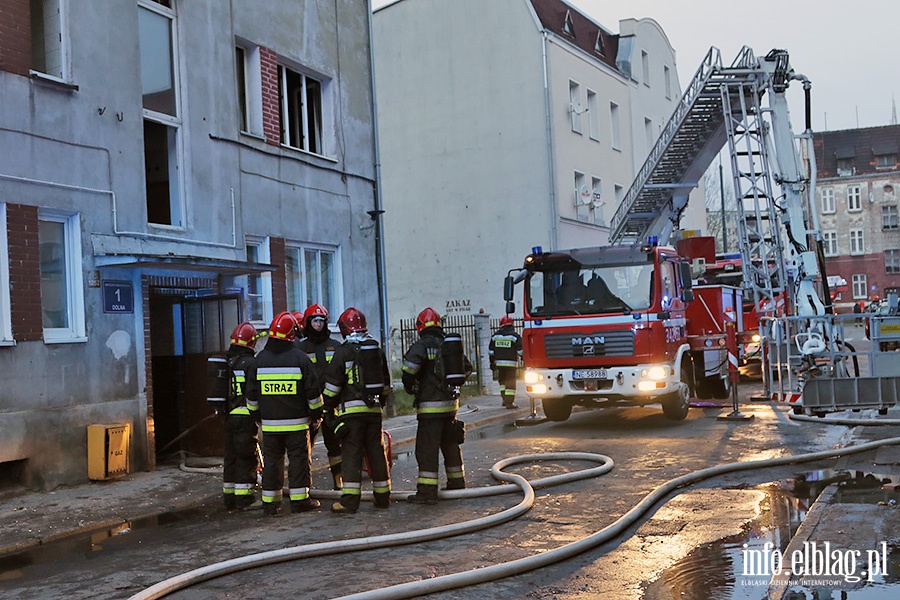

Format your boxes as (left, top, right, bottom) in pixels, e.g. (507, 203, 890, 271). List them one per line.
(814, 125, 900, 310)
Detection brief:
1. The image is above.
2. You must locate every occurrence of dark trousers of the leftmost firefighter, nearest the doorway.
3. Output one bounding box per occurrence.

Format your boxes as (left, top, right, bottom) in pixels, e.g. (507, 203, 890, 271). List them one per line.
(222, 413, 257, 508)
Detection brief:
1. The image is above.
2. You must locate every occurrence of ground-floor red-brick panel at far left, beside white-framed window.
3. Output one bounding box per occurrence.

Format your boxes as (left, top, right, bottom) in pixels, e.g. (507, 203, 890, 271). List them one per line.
(6, 204, 44, 342)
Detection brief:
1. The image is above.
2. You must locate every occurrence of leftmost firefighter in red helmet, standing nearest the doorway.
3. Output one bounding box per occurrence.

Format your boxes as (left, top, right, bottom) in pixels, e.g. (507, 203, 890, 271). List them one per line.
(222, 323, 258, 509)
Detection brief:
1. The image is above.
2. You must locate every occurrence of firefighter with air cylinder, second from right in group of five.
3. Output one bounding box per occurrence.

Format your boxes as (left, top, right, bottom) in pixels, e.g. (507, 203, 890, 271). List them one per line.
(324, 307, 391, 514)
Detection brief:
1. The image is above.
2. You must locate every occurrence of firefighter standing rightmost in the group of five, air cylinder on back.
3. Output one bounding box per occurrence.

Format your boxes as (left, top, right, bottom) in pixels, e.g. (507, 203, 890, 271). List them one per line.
(403, 308, 472, 504)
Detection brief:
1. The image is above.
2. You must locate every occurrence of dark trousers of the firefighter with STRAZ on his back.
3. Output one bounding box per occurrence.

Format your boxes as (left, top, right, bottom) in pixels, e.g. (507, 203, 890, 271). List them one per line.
(263, 429, 312, 504)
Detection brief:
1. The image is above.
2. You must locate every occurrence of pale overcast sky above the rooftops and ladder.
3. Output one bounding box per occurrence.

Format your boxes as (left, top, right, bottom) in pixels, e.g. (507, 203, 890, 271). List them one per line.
(373, 0, 900, 133)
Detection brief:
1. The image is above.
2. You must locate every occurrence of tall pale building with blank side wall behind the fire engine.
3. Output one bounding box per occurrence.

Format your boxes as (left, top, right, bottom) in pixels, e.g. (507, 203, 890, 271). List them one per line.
(374, 0, 705, 360)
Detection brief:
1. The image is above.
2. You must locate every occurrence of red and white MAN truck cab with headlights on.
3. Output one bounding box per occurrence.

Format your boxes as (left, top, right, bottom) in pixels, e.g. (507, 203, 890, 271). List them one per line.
(507, 241, 693, 420)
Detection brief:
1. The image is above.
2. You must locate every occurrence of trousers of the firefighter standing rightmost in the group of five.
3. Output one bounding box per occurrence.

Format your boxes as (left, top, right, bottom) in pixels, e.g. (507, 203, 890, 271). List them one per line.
(416, 413, 466, 498)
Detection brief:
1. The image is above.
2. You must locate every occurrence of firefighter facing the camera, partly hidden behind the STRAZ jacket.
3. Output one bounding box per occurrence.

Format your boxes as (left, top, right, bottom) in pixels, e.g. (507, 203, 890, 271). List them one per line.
(294, 304, 343, 490)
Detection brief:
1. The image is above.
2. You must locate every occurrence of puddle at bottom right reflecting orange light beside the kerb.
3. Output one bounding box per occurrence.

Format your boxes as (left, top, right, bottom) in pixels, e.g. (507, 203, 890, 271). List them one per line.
(645, 470, 900, 600)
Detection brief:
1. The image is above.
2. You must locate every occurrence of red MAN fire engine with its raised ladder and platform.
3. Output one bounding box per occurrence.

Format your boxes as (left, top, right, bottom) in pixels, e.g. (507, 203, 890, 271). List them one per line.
(504, 47, 900, 420)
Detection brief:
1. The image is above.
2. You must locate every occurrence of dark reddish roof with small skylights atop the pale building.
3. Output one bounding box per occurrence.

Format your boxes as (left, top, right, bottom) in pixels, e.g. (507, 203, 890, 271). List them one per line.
(531, 0, 619, 71)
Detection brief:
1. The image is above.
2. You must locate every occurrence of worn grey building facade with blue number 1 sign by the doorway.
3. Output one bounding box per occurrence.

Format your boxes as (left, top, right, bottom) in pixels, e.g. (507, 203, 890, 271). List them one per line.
(0, 0, 383, 489)
